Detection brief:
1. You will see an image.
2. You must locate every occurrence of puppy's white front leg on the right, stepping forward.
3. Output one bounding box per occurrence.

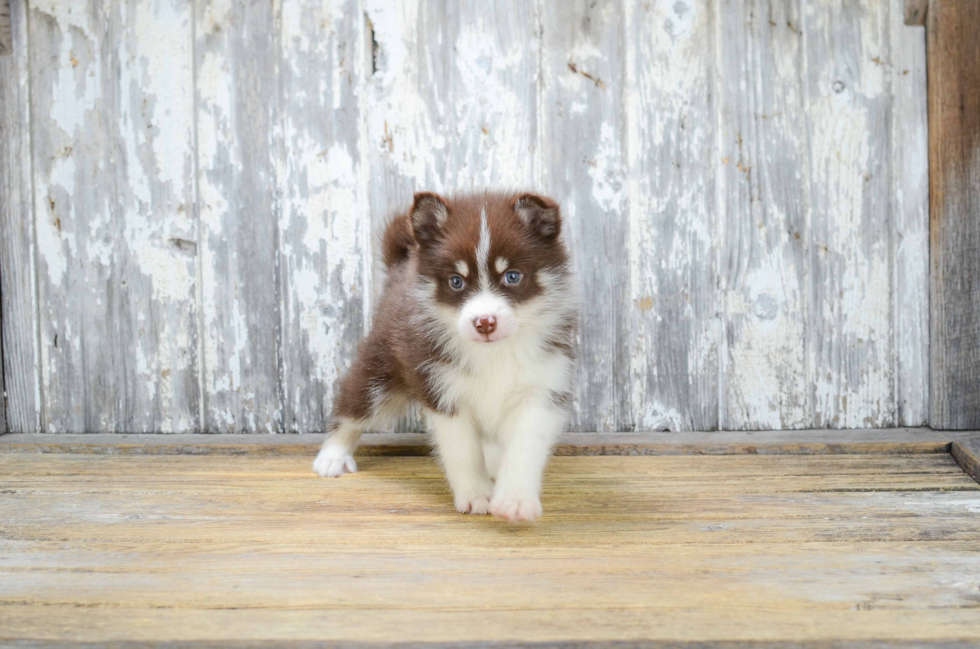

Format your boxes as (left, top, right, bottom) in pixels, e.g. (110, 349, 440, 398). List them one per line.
(490, 399, 566, 523)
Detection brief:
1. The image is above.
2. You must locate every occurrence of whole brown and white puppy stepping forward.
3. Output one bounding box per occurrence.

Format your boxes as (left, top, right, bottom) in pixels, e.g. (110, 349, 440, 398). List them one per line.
(313, 193, 578, 522)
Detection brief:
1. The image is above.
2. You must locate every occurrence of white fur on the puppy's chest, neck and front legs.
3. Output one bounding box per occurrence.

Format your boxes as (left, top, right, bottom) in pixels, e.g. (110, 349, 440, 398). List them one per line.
(426, 275, 576, 522)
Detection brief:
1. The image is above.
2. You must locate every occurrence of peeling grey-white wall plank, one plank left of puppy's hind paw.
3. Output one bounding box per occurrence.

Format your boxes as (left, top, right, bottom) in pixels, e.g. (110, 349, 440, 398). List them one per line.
(194, 0, 282, 432)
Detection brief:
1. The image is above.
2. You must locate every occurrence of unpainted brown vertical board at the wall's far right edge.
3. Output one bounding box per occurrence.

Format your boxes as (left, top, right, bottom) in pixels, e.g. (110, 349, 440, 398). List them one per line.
(927, 0, 980, 428)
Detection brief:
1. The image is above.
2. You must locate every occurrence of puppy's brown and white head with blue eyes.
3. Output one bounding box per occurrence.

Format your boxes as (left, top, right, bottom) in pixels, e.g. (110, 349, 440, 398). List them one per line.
(411, 193, 568, 344)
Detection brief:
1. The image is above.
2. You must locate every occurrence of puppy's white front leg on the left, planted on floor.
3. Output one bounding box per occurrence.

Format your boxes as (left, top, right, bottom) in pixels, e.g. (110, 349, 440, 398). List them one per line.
(426, 411, 493, 514)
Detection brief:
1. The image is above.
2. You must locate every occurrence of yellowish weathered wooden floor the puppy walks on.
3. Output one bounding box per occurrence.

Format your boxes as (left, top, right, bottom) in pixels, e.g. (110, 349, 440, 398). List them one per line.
(0, 452, 980, 646)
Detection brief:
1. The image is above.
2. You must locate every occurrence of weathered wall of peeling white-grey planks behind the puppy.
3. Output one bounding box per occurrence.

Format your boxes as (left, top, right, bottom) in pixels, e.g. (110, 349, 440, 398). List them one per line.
(0, 0, 929, 432)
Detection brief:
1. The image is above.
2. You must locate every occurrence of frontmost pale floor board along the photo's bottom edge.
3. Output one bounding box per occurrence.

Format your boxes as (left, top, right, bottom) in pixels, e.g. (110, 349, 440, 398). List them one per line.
(0, 604, 978, 647)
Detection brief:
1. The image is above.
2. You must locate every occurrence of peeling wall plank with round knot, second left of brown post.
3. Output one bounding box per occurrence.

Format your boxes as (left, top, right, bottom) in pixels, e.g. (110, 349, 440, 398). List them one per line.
(802, 0, 896, 428)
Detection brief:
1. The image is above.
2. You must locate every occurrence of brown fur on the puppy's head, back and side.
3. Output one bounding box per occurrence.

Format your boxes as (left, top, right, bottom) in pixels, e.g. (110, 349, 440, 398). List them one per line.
(334, 193, 574, 428)
